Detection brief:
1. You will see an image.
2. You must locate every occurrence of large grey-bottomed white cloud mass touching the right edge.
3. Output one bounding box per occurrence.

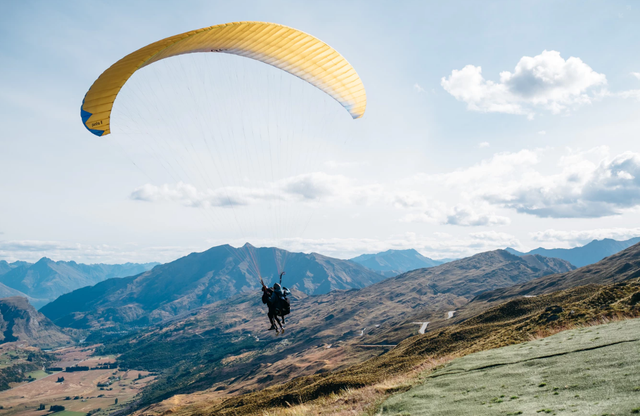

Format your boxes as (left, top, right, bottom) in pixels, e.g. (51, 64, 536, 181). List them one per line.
(422, 147, 640, 219)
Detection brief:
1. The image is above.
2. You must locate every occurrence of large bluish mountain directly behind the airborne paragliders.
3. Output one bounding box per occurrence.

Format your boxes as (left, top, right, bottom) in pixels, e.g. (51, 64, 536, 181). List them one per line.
(41, 244, 384, 328)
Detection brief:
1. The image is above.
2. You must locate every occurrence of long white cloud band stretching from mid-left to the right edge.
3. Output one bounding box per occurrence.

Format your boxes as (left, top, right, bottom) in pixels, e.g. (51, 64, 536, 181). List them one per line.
(130, 146, 640, 227)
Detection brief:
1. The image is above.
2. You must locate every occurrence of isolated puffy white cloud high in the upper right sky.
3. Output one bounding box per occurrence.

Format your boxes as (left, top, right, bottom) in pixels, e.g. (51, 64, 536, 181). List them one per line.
(440, 50, 607, 119)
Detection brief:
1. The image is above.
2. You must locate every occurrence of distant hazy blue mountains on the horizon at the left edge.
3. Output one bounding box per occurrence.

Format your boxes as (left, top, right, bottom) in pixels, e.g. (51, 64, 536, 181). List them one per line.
(0, 257, 158, 308)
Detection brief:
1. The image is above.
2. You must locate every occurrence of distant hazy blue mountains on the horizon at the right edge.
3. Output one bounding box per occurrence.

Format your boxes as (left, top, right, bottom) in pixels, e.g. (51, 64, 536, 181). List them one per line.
(506, 237, 640, 267)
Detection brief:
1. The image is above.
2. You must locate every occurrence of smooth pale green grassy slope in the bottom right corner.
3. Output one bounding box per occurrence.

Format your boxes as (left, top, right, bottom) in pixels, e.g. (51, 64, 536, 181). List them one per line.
(381, 319, 640, 416)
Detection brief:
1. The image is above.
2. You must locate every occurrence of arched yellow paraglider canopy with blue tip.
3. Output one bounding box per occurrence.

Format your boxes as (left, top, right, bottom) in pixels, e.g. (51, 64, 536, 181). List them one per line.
(80, 22, 367, 136)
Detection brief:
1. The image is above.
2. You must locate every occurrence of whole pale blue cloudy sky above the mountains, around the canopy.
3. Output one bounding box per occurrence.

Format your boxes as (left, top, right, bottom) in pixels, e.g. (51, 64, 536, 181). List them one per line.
(0, 0, 640, 263)
